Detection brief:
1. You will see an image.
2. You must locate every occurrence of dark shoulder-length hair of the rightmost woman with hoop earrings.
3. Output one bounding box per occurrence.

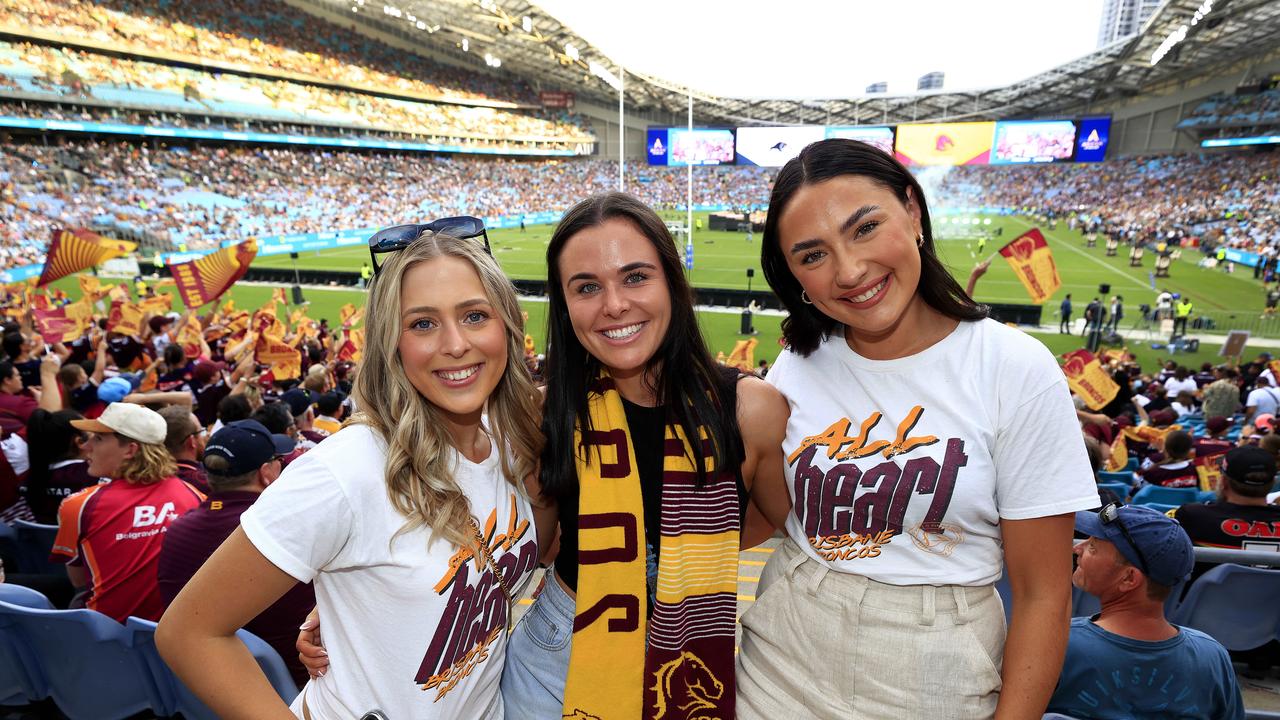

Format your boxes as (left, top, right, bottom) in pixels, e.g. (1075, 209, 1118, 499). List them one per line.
(760, 138, 987, 356)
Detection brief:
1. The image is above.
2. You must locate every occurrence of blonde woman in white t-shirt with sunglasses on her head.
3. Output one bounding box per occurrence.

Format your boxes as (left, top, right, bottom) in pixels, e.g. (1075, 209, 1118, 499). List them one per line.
(156, 226, 554, 720)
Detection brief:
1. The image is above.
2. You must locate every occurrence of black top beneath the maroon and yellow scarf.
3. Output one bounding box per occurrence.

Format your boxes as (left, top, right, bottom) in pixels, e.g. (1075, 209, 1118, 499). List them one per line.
(556, 370, 748, 591)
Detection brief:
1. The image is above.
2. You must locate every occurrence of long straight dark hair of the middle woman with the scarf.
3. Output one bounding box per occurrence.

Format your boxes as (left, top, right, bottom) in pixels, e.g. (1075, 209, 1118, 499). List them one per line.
(541, 192, 739, 498)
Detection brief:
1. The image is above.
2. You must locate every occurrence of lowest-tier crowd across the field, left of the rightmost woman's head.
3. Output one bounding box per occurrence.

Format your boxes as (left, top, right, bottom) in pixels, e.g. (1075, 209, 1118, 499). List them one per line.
(0, 141, 771, 254)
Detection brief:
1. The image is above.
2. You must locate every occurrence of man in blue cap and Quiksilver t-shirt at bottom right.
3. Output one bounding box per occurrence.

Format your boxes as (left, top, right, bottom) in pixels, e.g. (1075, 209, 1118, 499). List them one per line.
(1048, 505, 1244, 720)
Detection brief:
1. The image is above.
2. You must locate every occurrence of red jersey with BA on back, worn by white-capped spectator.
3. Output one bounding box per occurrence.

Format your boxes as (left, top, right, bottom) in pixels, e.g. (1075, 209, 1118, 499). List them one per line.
(51, 478, 205, 623)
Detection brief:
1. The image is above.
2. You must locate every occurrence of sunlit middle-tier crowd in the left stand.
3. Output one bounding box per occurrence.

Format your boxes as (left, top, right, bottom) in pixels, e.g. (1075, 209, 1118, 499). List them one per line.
(0, 42, 594, 146)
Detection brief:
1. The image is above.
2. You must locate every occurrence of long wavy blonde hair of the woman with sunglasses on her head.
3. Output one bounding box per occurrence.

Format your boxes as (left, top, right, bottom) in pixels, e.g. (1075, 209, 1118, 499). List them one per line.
(351, 232, 543, 547)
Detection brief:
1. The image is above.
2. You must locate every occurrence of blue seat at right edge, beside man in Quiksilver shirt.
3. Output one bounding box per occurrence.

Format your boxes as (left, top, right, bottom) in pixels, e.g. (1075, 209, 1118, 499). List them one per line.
(1170, 564, 1280, 651)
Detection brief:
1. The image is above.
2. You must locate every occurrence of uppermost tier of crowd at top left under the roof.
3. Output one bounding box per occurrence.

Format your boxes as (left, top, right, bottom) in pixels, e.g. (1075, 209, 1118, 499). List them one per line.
(0, 0, 536, 104)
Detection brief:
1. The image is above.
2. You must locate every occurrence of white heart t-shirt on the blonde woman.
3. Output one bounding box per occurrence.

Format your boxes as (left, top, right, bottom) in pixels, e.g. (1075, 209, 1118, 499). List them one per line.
(241, 425, 538, 720)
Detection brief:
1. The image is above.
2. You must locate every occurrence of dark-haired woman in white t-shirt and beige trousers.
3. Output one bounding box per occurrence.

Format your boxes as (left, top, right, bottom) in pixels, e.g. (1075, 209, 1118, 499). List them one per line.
(737, 140, 1098, 719)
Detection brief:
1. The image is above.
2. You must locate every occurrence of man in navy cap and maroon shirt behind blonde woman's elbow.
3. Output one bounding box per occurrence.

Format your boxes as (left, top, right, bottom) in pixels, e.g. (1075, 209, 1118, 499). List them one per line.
(157, 420, 316, 684)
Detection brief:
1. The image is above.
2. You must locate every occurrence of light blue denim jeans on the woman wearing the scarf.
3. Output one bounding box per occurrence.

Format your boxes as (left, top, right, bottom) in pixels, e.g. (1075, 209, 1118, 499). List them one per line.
(502, 570, 576, 720)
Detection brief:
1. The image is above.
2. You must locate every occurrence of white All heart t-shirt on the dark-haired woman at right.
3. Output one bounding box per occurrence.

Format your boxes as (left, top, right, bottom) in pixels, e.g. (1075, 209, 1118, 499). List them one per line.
(768, 320, 1101, 585)
